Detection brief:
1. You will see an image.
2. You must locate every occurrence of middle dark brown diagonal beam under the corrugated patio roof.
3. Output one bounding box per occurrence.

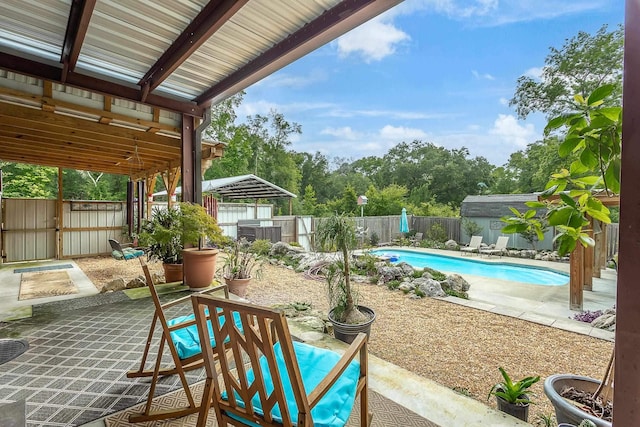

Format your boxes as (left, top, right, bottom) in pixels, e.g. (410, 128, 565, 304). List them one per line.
(138, 0, 248, 97)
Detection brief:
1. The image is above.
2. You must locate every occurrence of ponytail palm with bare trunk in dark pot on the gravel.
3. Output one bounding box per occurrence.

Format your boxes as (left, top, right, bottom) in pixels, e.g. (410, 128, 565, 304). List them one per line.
(316, 214, 376, 343)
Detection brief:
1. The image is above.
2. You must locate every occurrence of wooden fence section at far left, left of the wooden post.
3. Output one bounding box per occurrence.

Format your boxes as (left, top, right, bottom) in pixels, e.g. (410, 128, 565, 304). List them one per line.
(1, 199, 56, 262)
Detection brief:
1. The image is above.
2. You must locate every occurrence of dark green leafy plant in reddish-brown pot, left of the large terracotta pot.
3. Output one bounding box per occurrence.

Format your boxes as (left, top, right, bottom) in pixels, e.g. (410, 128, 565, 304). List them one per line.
(139, 207, 183, 283)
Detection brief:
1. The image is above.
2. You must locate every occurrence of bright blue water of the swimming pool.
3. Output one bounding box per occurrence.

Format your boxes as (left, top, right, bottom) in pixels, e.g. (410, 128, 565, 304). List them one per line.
(371, 249, 569, 286)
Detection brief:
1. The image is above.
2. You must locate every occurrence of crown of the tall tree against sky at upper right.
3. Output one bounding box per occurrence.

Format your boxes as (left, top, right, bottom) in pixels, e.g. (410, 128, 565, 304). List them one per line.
(509, 25, 624, 119)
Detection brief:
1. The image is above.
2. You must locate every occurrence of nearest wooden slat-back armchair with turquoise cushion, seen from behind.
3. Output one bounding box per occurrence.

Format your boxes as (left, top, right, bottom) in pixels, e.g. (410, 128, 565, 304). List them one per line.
(192, 295, 371, 427)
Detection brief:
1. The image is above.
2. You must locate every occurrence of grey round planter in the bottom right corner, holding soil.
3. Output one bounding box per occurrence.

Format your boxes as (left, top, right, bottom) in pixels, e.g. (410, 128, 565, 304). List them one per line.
(544, 375, 611, 427)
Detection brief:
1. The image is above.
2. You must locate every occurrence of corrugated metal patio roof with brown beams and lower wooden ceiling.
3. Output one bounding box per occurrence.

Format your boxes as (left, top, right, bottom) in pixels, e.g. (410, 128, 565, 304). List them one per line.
(0, 0, 401, 176)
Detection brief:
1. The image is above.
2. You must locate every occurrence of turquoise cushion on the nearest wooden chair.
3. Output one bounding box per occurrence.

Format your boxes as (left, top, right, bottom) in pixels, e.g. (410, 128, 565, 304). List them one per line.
(222, 342, 360, 427)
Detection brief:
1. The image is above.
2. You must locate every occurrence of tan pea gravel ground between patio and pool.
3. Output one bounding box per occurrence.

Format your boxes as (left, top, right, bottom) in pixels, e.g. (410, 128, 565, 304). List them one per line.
(75, 257, 613, 424)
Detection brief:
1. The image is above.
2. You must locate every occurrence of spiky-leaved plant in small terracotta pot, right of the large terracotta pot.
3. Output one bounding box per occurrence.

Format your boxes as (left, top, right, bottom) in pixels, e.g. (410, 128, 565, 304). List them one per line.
(222, 239, 263, 298)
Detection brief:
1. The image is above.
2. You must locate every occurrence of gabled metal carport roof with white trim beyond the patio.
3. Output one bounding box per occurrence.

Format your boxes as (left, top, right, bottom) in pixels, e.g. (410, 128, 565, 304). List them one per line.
(153, 174, 297, 200)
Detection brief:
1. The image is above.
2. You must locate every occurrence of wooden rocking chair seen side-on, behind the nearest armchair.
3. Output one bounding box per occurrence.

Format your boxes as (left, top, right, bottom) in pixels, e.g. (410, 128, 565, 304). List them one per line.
(127, 258, 234, 423)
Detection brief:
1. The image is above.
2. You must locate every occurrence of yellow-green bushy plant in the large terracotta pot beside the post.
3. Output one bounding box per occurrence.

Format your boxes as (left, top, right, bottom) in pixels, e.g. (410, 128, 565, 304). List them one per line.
(180, 203, 225, 288)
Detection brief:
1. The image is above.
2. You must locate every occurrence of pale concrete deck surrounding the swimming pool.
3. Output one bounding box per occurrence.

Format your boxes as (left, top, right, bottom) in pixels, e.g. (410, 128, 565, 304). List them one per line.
(384, 246, 617, 341)
